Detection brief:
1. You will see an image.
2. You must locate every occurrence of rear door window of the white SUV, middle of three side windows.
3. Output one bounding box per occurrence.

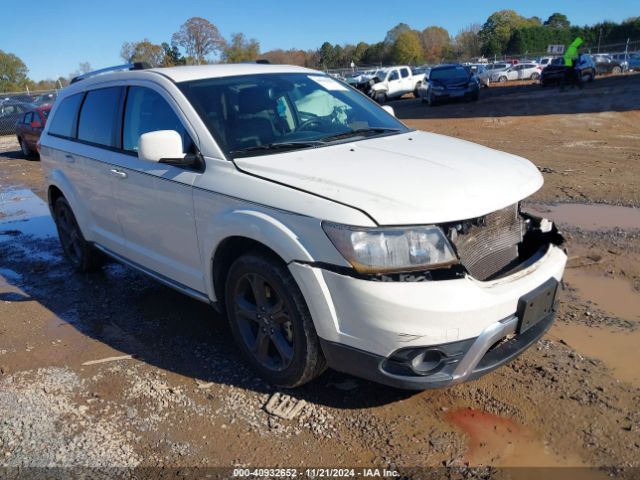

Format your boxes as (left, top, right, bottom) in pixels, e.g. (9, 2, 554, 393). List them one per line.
(77, 87, 122, 147)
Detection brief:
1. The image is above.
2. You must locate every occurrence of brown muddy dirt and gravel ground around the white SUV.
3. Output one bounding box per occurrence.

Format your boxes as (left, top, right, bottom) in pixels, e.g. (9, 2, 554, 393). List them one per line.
(0, 75, 640, 478)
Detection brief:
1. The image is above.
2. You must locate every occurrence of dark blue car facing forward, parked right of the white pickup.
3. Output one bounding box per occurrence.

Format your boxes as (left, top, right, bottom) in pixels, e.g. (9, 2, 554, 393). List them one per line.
(426, 65, 480, 105)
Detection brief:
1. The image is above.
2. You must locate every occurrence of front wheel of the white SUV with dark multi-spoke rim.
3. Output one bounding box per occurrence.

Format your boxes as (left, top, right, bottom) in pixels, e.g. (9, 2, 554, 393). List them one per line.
(225, 252, 326, 388)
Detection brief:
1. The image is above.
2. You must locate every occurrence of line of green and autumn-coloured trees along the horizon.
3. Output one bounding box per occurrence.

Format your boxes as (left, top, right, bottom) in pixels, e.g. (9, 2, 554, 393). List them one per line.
(0, 10, 640, 92)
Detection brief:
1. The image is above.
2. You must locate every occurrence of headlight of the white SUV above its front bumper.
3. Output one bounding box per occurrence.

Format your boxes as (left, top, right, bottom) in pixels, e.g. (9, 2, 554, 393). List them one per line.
(322, 222, 458, 273)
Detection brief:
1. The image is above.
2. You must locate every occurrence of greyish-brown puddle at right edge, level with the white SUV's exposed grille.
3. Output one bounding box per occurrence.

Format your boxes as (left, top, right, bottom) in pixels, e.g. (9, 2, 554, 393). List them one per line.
(524, 203, 640, 231)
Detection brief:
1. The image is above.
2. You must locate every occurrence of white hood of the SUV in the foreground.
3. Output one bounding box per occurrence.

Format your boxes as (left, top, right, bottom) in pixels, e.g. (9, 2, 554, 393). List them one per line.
(234, 131, 543, 225)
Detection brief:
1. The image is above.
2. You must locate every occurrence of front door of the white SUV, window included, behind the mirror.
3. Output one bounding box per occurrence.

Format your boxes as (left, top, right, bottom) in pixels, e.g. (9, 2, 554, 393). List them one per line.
(111, 84, 205, 292)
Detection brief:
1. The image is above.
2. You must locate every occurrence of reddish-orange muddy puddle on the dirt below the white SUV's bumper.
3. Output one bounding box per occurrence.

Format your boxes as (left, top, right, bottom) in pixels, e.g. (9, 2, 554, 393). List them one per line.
(445, 409, 606, 479)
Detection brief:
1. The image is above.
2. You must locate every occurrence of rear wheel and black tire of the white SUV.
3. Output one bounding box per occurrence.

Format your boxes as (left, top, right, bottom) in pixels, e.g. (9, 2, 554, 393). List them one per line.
(53, 197, 105, 273)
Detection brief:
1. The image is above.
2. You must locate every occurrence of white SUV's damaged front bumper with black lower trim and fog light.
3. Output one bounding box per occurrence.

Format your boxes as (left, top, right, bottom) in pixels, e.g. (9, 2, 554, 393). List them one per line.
(290, 214, 567, 389)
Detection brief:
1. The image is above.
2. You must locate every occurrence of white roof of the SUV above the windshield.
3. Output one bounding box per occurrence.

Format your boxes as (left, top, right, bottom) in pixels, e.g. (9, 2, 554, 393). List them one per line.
(146, 63, 320, 82)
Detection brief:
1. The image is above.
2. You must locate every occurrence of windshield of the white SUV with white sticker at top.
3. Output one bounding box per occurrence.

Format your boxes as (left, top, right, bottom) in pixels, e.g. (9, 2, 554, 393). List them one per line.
(179, 73, 408, 157)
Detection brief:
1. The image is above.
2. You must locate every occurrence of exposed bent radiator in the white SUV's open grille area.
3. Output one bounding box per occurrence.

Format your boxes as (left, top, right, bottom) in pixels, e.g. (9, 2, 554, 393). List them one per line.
(453, 204, 522, 280)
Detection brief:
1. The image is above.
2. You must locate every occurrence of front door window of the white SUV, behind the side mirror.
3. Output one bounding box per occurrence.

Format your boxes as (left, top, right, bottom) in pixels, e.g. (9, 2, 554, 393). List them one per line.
(122, 87, 193, 153)
